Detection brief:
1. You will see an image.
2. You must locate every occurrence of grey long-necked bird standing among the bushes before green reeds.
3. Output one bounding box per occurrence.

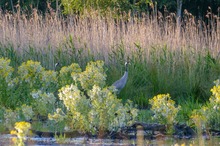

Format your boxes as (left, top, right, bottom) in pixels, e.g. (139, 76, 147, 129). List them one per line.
(112, 62, 129, 93)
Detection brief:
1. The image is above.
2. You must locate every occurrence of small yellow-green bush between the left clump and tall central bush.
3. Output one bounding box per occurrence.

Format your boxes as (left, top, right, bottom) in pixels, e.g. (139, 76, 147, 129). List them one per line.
(59, 63, 82, 87)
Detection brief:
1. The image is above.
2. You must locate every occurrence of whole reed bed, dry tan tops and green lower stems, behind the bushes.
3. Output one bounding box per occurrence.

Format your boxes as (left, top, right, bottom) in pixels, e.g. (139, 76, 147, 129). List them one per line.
(0, 10, 220, 107)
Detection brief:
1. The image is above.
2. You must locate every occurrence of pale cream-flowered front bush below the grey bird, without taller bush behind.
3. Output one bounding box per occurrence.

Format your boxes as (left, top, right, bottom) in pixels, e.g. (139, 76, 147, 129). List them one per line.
(56, 84, 138, 133)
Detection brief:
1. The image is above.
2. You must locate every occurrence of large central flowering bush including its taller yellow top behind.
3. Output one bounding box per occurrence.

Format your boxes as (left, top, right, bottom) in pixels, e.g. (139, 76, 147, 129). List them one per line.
(49, 61, 138, 134)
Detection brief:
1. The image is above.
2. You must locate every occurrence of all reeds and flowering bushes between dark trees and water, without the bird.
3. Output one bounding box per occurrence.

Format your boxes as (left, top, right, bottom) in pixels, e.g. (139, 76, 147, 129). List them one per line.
(0, 1, 220, 145)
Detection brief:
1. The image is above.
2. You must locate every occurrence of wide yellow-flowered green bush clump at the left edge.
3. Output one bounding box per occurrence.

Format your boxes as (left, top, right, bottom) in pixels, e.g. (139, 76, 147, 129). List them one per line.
(0, 58, 58, 125)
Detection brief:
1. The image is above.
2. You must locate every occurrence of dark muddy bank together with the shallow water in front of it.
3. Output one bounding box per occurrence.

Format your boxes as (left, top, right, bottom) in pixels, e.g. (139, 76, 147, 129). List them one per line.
(0, 123, 220, 146)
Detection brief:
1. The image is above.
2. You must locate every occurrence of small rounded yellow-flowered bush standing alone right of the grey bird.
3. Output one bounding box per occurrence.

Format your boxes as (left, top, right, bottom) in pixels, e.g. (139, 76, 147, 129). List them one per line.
(149, 94, 180, 124)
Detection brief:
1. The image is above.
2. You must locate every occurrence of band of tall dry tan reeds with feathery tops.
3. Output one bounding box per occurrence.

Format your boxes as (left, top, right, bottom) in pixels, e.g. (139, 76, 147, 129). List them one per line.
(0, 10, 220, 62)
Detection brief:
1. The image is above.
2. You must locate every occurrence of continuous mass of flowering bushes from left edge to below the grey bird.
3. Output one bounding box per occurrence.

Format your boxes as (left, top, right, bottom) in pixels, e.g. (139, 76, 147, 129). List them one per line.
(0, 59, 137, 133)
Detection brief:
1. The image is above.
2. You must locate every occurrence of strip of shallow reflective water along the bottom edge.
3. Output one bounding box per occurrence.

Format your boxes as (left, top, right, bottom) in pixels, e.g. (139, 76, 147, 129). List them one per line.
(0, 134, 220, 146)
